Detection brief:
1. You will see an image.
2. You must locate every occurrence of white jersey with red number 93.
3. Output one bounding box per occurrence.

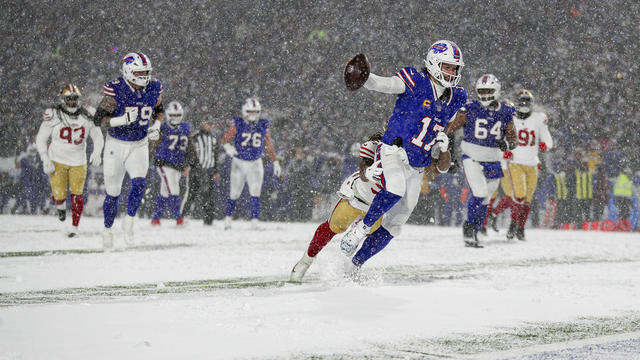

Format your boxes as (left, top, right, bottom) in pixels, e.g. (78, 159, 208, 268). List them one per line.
(36, 107, 102, 166)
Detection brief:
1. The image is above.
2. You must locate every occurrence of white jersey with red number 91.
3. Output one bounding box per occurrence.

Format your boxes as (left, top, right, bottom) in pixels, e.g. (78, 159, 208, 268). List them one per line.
(513, 111, 553, 166)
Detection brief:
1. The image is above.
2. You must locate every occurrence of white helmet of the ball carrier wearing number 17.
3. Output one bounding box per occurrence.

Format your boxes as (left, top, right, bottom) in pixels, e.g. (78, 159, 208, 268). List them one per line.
(424, 40, 464, 87)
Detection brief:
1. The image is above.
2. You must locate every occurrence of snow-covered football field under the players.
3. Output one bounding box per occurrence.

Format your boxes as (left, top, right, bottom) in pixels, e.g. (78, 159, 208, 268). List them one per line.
(0, 215, 640, 360)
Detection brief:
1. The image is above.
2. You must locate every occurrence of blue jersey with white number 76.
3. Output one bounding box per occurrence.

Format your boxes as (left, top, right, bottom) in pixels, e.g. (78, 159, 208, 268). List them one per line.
(233, 117, 269, 160)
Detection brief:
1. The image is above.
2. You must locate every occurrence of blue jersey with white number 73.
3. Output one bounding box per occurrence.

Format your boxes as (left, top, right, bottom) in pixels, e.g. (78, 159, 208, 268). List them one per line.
(155, 122, 191, 168)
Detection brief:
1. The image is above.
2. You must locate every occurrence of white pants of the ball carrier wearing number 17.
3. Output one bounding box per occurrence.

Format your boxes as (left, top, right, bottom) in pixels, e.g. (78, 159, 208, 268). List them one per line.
(380, 144, 424, 236)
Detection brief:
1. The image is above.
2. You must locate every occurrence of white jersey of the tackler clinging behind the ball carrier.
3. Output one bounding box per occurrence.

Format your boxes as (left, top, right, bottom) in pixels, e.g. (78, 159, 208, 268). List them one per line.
(338, 141, 382, 211)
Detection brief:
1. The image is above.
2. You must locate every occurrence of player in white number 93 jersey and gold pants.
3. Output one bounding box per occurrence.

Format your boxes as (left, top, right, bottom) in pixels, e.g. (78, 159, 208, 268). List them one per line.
(36, 84, 104, 237)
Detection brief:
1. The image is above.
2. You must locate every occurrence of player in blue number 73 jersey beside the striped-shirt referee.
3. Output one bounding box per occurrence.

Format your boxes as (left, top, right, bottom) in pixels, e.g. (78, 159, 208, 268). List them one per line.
(151, 101, 191, 225)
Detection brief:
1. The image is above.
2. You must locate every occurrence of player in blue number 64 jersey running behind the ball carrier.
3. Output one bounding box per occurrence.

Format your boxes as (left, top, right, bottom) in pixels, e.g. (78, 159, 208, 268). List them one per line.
(447, 74, 517, 247)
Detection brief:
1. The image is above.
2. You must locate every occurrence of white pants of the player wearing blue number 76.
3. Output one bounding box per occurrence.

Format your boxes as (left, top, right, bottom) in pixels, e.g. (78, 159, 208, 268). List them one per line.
(229, 157, 264, 200)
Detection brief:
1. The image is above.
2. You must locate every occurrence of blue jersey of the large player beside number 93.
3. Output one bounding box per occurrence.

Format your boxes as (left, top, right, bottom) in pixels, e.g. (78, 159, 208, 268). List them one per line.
(104, 77, 162, 141)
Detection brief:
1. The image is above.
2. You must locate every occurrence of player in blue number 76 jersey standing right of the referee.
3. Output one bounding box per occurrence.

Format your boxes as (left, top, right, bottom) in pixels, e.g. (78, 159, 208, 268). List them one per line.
(222, 98, 282, 230)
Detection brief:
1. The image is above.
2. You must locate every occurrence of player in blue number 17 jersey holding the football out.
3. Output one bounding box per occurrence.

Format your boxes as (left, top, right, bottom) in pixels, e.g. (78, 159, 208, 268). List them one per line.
(341, 40, 467, 270)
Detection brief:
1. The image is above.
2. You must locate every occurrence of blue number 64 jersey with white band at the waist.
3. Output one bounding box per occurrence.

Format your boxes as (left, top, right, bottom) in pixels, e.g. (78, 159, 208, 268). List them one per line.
(461, 100, 515, 161)
